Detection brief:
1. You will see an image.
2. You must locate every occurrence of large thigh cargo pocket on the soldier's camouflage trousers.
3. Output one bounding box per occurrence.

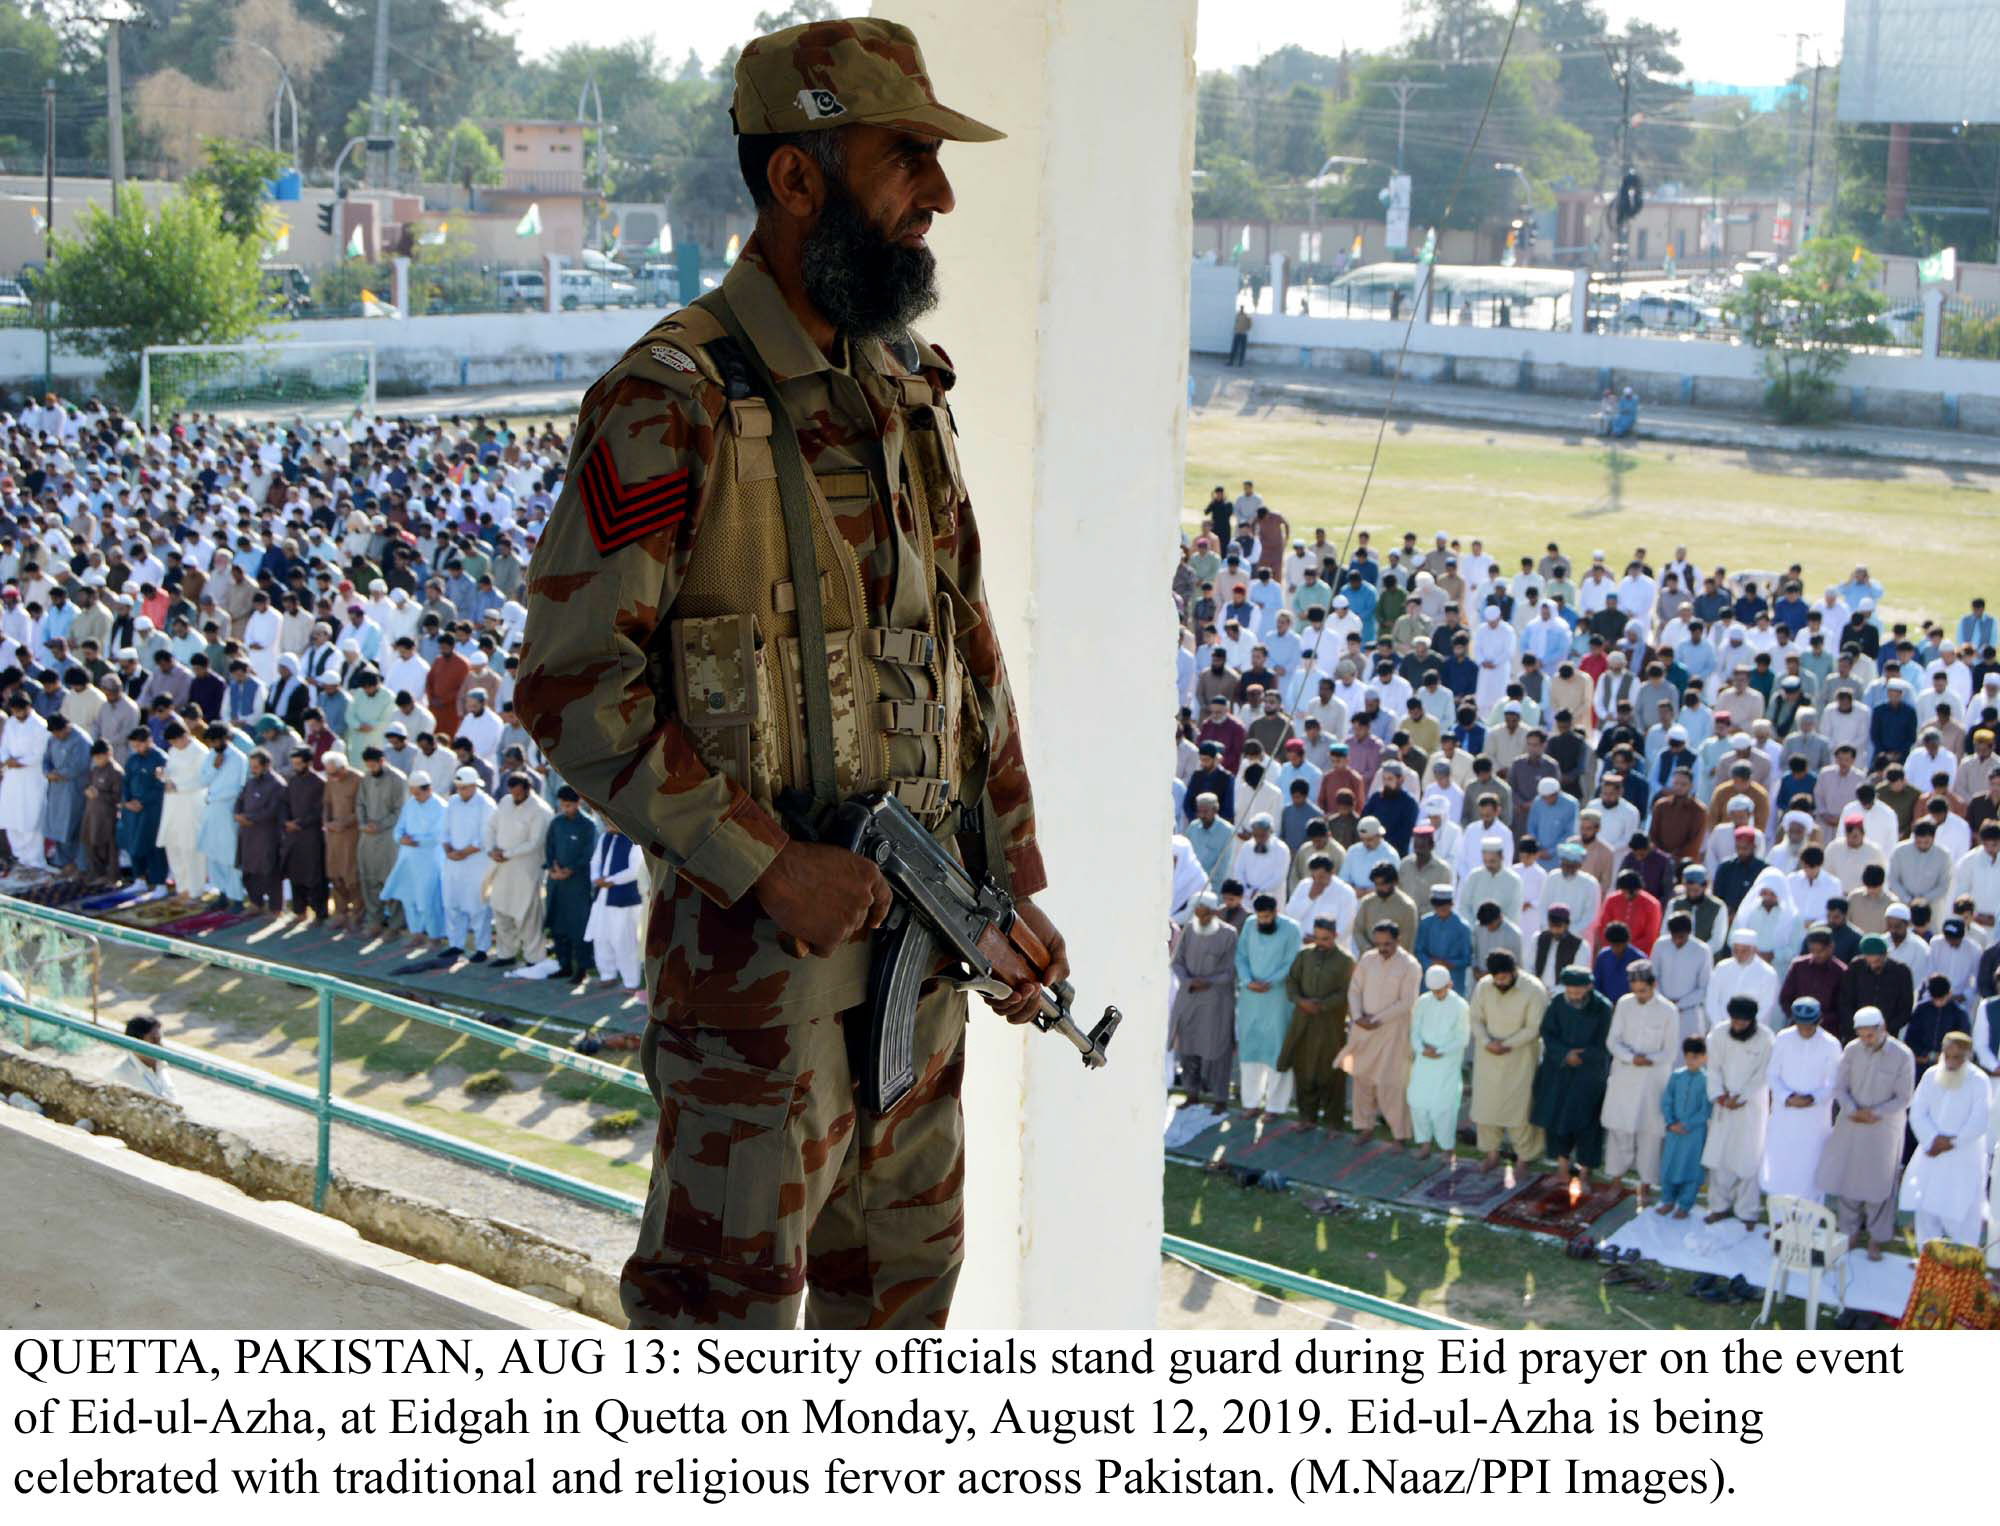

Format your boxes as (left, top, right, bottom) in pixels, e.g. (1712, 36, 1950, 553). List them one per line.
(660, 1052, 804, 1274)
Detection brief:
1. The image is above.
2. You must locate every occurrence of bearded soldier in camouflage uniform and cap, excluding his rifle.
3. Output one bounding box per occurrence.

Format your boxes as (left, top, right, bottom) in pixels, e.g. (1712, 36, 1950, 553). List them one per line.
(516, 20, 1068, 1328)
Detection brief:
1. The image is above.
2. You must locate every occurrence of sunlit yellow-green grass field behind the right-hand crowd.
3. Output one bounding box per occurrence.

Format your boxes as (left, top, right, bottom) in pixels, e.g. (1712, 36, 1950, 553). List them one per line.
(1182, 402, 2000, 620)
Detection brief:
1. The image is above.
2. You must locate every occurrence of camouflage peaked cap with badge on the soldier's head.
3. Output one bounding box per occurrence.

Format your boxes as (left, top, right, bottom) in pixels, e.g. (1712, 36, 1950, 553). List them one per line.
(730, 18, 1006, 144)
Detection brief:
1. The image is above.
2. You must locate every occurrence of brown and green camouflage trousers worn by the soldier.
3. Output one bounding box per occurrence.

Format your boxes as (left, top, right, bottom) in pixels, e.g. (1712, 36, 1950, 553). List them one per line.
(620, 984, 966, 1330)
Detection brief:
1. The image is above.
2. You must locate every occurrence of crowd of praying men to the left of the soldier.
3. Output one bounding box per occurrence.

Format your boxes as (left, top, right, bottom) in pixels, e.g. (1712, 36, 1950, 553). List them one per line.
(0, 394, 644, 990)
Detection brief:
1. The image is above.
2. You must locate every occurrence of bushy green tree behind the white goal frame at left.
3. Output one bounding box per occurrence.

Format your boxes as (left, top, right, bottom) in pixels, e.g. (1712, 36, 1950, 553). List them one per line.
(46, 188, 264, 394)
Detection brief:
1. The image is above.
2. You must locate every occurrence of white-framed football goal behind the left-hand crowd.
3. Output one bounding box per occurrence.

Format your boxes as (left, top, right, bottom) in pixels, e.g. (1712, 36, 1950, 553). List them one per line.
(138, 340, 376, 430)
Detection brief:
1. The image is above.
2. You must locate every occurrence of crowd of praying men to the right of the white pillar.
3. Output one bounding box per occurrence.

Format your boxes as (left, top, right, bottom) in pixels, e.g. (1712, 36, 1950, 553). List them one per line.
(1168, 482, 2000, 1262)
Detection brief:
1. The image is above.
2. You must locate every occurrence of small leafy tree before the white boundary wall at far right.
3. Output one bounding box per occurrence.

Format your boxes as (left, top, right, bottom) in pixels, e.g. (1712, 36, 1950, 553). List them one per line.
(1722, 238, 1890, 424)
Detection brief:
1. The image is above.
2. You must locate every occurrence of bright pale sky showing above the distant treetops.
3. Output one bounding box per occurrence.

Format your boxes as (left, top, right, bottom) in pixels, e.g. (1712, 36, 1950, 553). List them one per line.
(496, 0, 1844, 84)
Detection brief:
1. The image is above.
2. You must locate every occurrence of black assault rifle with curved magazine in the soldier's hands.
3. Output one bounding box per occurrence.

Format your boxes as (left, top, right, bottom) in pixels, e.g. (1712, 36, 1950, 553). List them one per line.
(816, 792, 1124, 1114)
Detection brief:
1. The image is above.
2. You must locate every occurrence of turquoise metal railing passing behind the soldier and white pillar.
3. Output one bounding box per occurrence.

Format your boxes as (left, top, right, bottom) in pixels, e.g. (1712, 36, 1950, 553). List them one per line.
(0, 896, 1472, 1330)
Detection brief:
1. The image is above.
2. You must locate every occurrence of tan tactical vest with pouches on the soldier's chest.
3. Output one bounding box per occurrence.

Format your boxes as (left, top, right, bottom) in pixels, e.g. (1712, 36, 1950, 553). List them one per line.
(648, 298, 986, 830)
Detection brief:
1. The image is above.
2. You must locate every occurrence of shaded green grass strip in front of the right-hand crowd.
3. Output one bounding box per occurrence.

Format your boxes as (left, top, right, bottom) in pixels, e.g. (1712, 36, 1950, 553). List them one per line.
(1164, 1160, 1802, 1330)
